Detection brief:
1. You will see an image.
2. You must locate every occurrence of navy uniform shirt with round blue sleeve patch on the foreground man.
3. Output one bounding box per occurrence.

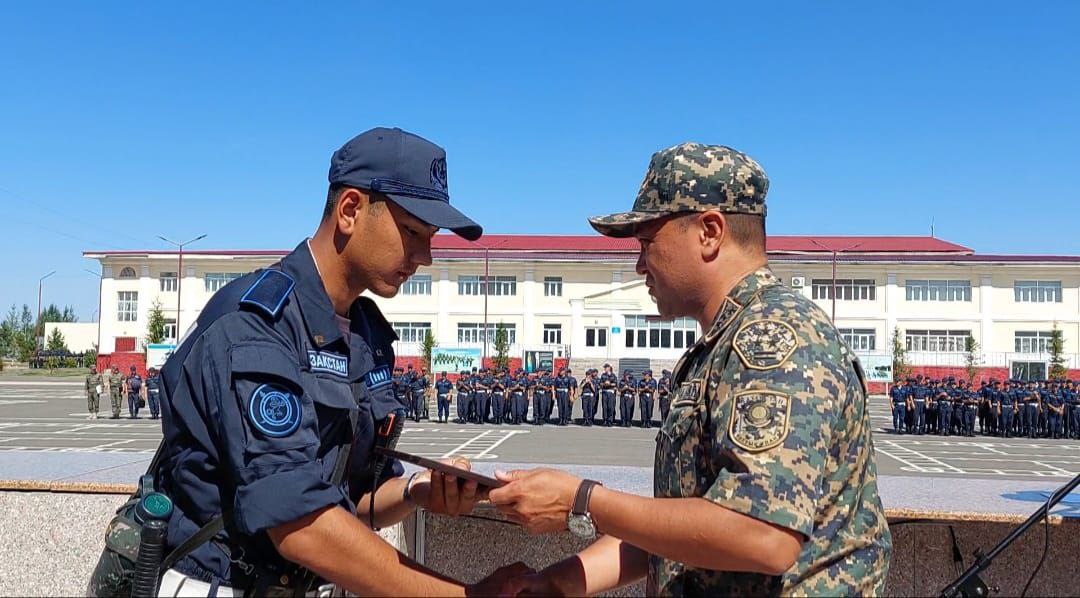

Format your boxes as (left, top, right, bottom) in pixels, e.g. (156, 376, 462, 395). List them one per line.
(157, 243, 403, 587)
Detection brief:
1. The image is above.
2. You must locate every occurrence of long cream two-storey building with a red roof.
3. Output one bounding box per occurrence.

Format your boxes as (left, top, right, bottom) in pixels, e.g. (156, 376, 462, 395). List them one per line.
(84, 235, 1080, 376)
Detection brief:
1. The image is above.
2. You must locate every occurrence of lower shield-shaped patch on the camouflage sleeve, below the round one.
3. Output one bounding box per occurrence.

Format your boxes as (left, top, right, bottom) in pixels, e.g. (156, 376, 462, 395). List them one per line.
(728, 391, 792, 452)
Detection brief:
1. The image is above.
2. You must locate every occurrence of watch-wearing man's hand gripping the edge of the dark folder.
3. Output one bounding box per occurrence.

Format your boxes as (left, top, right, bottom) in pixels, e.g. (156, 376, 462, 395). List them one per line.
(488, 468, 581, 533)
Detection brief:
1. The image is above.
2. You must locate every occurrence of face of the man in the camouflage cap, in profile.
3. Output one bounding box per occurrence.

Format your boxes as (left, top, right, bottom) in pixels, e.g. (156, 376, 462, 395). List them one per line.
(634, 211, 701, 320)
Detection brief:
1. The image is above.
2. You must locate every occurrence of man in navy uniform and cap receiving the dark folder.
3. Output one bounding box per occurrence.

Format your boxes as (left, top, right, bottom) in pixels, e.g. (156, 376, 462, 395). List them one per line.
(102, 128, 527, 596)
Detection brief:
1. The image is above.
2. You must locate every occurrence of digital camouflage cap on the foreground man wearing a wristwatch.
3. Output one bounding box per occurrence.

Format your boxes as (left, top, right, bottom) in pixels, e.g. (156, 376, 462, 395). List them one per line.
(589, 142, 769, 236)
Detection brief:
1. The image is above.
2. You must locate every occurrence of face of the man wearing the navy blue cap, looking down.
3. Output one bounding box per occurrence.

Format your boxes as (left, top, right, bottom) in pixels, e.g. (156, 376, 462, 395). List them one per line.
(348, 193, 438, 298)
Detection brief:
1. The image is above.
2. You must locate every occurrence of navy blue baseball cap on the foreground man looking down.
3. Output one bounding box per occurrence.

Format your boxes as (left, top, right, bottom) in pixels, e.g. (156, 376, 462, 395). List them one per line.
(328, 126, 484, 241)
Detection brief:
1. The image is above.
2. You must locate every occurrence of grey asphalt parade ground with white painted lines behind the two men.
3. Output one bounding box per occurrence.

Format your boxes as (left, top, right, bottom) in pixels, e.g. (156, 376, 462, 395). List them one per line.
(0, 379, 1080, 481)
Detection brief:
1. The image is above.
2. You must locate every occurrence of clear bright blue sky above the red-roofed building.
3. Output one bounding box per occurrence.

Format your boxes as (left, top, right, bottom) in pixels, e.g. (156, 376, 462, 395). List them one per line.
(0, 1, 1080, 320)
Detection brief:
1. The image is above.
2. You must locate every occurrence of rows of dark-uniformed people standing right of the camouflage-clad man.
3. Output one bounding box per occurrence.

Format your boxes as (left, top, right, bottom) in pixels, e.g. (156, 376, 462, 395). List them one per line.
(889, 376, 1080, 439)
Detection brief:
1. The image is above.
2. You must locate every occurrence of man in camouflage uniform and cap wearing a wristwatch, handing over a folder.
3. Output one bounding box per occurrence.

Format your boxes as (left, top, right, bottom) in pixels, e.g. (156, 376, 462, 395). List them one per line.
(489, 144, 892, 596)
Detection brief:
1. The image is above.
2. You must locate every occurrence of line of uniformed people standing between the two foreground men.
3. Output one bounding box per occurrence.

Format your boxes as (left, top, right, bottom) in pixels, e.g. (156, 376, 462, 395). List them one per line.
(392, 364, 671, 427)
